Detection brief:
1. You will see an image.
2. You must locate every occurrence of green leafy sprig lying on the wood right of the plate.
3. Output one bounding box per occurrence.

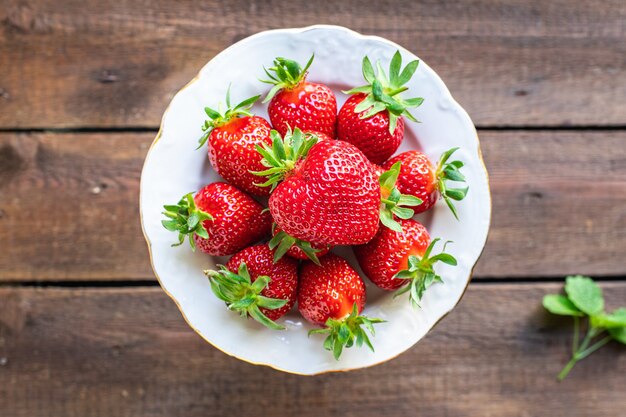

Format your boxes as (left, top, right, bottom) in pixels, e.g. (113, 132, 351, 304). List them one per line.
(543, 275, 626, 381)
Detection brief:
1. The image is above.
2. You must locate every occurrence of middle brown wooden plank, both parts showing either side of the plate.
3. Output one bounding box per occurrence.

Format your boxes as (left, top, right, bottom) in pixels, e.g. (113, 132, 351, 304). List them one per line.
(0, 131, 626, 281)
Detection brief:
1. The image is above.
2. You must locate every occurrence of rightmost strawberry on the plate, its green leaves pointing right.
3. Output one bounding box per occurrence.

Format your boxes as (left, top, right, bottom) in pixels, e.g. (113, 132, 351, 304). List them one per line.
(383, 148, 469, 219)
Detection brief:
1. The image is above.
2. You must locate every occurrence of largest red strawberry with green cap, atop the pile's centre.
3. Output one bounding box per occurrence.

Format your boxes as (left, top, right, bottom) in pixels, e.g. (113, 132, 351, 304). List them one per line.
(257, 129, 380, 246)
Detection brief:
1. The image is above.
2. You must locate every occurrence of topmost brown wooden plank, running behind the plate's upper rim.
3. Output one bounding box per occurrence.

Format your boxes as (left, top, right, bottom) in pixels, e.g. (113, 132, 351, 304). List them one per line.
(0, 0, 626, 128)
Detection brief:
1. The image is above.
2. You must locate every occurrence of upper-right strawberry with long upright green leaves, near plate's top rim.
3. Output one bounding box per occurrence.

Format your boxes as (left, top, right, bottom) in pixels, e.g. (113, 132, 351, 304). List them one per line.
(337, 51, 424, 164)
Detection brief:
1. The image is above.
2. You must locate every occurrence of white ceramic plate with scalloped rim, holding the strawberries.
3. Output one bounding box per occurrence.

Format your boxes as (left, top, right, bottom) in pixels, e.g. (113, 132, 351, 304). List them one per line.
(141, 26, 491, 374)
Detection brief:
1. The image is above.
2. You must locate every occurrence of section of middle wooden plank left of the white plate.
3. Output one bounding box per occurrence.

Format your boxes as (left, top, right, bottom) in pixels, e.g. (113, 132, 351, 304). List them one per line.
(0, 134, 153, 280)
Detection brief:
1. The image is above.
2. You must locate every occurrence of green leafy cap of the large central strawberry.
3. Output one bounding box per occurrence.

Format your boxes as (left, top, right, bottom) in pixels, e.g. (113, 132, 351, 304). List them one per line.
(250, 128, 319, 191)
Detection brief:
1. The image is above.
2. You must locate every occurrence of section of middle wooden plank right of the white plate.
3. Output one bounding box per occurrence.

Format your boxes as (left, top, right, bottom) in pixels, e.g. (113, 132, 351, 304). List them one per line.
(476, 131, 626, 277)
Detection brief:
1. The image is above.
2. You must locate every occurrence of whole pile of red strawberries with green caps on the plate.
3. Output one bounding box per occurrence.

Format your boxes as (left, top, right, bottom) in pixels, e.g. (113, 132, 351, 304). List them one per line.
(163, 52, 467, 358)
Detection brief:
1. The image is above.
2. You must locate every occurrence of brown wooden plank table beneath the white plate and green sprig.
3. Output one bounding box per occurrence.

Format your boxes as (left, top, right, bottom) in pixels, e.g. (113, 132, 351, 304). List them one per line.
(0, 0, 626, 417)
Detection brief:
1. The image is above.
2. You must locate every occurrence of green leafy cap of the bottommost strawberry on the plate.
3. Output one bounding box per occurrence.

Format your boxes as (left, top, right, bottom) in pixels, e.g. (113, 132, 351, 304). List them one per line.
(309, 303, 385, 360)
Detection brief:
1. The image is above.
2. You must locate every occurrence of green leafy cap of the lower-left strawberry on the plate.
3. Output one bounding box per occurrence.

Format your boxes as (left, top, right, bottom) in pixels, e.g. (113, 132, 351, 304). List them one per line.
(204, 262, 287, 330)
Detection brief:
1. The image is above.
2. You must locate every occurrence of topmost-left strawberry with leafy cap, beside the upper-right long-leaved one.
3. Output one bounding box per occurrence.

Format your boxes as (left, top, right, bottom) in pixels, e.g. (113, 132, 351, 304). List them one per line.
(263, 56, 337, 138)
